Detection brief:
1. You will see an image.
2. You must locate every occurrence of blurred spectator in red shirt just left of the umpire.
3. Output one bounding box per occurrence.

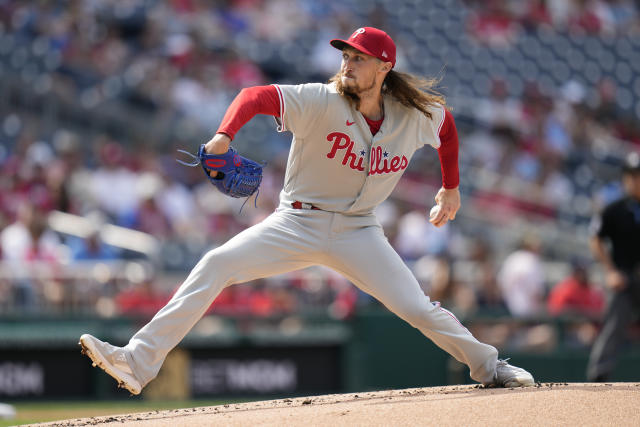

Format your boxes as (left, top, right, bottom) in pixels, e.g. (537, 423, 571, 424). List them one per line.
(547, 261, 604, 316)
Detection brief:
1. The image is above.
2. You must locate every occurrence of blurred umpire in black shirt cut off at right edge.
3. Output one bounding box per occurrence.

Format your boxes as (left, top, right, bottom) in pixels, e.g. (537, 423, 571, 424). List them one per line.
(587, 153, 640, 382)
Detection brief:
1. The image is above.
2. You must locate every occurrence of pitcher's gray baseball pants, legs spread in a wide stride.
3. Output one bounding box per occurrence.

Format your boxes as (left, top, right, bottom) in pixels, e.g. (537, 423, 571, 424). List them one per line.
(125, 207, 498, 386)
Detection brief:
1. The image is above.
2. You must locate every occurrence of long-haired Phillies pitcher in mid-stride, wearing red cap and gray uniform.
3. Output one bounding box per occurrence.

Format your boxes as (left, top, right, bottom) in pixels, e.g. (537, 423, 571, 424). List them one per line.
(80, 27, 534, 394)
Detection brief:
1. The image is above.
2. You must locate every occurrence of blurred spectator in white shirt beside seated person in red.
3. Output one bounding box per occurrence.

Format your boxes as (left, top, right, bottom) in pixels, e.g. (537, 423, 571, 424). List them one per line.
(498, 234, 545, 317)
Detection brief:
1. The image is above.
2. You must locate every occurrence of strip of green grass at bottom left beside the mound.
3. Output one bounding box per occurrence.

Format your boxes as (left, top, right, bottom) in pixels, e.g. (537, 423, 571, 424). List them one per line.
(0, 399, 255, 427)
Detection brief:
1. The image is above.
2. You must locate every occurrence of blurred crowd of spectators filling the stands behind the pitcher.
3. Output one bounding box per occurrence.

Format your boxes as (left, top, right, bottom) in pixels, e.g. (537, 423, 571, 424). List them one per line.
(0, 0, 640, 352)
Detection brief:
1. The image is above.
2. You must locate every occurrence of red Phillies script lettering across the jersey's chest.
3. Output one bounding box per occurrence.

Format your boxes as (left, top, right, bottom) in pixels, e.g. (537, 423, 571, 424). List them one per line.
(327, 132, 409, 175)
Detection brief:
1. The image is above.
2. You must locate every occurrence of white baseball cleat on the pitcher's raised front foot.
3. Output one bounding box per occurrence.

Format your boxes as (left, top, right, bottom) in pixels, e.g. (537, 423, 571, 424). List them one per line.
(78, 334, 142, 394)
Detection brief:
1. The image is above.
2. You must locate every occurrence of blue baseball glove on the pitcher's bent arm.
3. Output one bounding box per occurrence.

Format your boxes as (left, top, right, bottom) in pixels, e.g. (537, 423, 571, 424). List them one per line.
(178, 144, 262, 197)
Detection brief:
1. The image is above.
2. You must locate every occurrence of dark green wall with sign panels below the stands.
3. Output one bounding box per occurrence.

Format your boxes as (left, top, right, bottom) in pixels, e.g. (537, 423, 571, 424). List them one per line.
(0, 309, 640, 401)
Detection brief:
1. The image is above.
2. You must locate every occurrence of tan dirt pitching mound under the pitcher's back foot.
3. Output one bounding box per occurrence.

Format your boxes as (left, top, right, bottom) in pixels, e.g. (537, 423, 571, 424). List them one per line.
(33, 383, 640, 427)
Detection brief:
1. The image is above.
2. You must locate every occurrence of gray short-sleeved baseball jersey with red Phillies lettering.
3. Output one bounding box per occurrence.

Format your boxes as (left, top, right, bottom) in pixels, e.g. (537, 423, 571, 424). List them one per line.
(275, 83, 444, 215)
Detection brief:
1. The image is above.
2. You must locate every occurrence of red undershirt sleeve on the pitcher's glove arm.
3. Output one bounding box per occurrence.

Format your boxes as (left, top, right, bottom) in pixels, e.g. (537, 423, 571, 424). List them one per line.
(216, 85, 280, 139)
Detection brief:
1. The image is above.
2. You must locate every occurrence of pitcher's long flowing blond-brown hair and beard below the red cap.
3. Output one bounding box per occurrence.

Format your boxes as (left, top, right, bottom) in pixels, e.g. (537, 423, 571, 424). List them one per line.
(329, 70, 446, 118)
